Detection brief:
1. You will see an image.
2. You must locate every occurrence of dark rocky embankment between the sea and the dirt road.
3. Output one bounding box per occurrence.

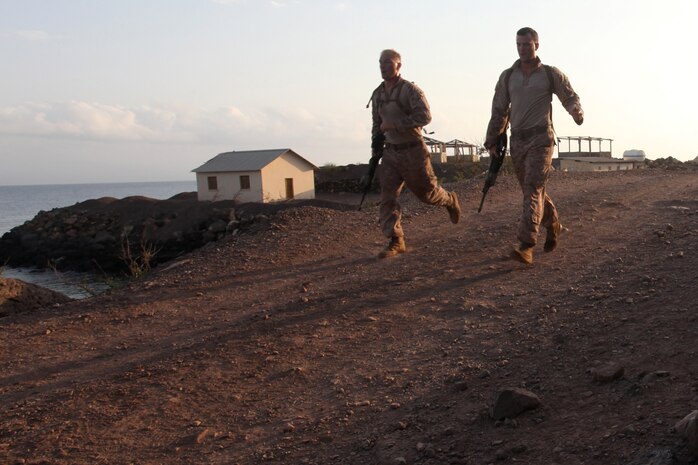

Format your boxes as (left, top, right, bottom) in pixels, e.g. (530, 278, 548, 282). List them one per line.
(0, 193, 354, 274)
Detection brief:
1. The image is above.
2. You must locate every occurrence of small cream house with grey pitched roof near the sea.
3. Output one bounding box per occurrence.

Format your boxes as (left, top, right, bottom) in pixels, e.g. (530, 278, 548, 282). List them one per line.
(192, 149, 317, 202)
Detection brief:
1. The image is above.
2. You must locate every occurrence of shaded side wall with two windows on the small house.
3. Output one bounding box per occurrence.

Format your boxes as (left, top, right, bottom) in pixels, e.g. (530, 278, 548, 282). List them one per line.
(196, 171, 263, 202)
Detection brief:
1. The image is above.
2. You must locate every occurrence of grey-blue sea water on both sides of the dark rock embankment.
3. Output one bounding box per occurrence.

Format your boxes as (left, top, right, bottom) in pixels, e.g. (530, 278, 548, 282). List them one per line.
(0, 180, 196, 298)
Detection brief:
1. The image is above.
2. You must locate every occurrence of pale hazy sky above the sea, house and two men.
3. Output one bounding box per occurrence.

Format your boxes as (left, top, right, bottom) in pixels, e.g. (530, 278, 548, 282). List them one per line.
(0, 0, 698, 185)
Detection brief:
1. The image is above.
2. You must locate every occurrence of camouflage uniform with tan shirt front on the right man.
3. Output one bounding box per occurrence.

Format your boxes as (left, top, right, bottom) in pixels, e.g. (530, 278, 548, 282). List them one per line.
(485, 58, 581, 246)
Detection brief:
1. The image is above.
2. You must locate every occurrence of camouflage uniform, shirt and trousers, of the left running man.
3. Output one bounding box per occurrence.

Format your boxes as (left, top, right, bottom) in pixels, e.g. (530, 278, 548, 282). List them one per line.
(371, 77, 457, 237)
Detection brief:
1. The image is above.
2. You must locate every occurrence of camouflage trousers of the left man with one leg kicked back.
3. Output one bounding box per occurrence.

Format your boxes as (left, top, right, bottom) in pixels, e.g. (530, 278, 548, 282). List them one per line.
(379, 143, 453, 237)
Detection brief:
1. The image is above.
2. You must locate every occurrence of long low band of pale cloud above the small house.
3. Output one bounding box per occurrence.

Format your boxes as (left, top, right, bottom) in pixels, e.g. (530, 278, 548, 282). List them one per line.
(0, 101, 362, 146)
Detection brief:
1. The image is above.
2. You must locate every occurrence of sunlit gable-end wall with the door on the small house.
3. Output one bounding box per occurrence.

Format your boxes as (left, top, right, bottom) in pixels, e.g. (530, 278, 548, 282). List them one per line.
(262, 152, 315, 202)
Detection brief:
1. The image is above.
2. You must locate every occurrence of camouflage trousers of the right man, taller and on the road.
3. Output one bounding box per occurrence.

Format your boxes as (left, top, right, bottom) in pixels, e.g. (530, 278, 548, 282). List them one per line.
(511, 137, 558, 245)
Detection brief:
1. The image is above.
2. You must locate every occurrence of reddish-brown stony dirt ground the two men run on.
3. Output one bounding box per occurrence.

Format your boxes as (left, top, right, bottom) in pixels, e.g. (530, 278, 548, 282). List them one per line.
(0, 169, 698, 465)
